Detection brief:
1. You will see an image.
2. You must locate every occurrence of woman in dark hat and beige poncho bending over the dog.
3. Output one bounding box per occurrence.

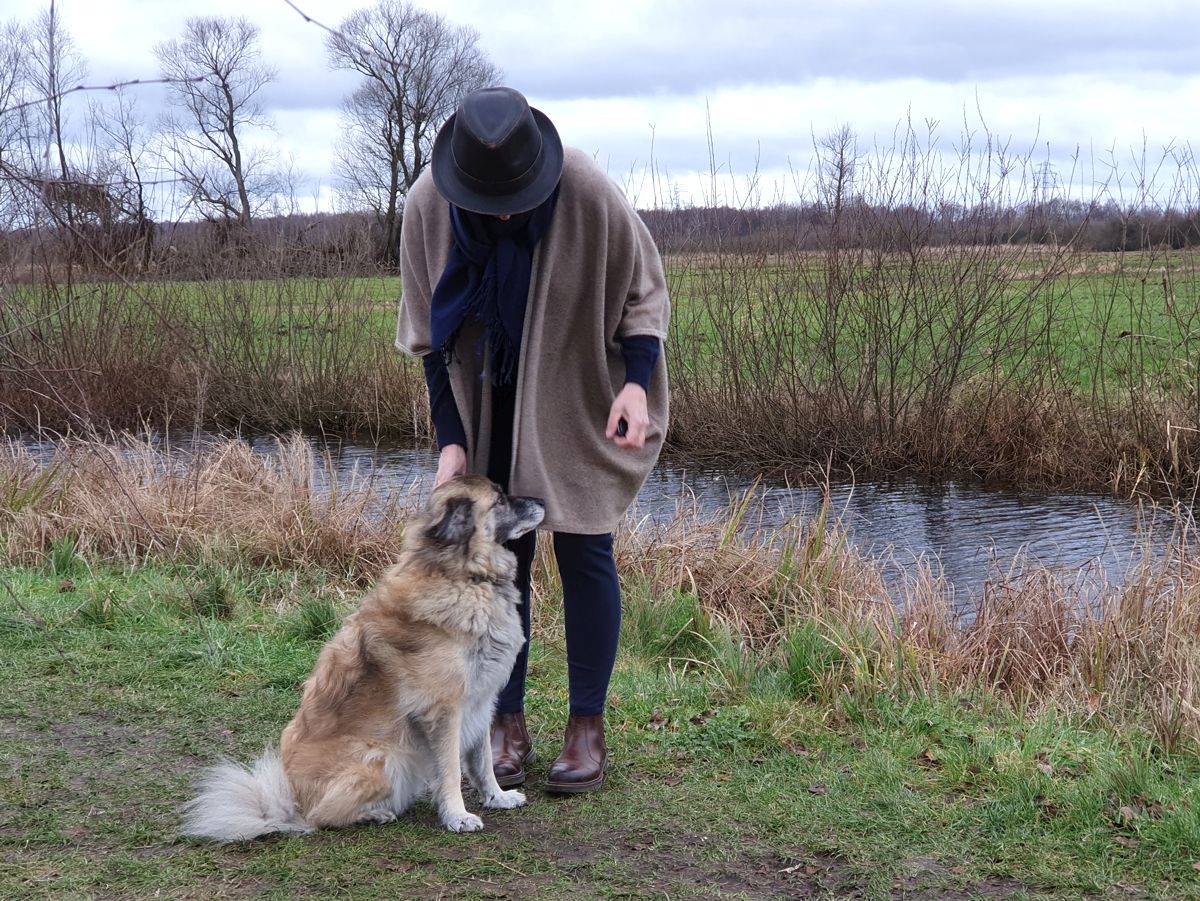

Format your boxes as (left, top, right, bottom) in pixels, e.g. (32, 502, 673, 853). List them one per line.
(396, 88, 670, 793)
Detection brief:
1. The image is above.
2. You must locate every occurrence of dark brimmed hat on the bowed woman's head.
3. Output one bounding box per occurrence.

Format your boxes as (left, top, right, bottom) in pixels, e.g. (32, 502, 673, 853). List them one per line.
(432, 88, 563, 216)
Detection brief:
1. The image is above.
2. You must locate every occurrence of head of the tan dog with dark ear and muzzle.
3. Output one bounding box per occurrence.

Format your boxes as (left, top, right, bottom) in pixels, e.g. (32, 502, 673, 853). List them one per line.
(422, 475, 546, 557)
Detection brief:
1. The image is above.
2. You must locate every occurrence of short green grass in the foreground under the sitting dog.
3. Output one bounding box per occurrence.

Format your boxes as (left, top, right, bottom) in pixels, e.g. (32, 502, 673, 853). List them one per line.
(0, 564, 1200, 897)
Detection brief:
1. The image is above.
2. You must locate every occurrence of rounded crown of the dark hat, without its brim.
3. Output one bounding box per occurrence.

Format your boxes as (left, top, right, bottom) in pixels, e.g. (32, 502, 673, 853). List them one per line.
(451, 88, 542, 188)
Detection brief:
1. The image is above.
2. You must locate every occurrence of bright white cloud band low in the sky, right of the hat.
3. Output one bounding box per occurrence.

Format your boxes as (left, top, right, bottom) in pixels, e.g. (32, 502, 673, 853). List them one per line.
(542, 76, 1200, 206)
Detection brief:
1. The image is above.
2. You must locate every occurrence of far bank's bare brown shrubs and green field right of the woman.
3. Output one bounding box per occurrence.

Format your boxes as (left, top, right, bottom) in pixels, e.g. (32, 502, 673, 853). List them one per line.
(668, 232, 1200, 493)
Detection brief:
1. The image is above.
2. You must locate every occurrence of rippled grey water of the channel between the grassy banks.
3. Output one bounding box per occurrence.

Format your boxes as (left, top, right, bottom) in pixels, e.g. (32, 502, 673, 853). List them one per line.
(16, 436, 1176, 597)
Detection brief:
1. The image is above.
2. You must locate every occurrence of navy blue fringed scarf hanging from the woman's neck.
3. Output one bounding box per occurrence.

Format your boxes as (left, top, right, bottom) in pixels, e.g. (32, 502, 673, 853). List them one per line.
(430, 188, 558, 385)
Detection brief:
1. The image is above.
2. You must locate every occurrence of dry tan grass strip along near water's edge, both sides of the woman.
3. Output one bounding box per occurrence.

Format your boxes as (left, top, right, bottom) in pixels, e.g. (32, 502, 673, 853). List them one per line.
(0, 439, 1200, 749)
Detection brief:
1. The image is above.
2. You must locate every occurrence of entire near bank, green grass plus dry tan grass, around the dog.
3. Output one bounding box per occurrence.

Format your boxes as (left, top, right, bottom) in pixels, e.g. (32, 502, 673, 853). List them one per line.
(0, 442, 1200, 897)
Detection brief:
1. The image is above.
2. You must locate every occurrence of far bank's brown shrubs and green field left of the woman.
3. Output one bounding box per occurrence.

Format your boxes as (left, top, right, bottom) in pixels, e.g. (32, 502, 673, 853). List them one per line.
(0, 274, 439, 440)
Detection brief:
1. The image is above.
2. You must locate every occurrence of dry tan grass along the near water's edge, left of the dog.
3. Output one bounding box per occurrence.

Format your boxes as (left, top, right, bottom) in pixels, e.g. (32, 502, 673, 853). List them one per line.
(0, 437, 404, 576)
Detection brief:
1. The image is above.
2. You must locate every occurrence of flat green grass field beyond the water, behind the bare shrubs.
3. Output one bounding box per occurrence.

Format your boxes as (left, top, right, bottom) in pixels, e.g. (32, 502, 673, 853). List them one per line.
(18, 252, 1200, 394)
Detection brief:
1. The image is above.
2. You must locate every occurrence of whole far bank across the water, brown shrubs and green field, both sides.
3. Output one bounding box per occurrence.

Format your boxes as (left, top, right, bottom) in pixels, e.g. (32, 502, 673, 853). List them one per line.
(0, 245, 1200, 495)
